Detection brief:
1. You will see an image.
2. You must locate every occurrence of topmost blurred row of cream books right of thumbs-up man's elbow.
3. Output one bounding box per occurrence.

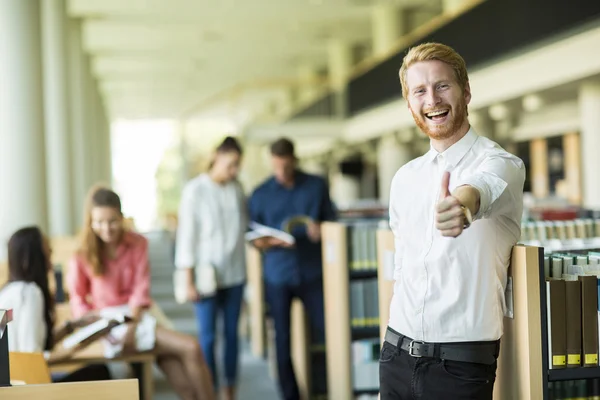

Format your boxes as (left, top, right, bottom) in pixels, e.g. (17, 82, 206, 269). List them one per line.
(521, 218, 600, 242)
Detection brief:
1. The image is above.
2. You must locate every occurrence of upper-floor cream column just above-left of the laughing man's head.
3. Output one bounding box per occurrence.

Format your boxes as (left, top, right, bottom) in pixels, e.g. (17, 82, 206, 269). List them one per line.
(371, 4, 403, 57)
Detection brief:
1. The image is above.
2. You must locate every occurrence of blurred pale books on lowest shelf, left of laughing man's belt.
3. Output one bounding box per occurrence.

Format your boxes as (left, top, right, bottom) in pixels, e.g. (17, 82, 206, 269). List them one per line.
(352, 338, 381, 392)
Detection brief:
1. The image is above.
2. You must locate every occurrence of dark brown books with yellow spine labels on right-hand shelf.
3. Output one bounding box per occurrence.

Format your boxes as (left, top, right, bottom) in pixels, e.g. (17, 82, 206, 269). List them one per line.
(544, 252, 600, 369)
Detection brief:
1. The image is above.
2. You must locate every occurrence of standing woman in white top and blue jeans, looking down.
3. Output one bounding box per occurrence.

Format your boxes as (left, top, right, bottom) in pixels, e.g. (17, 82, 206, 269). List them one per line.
(175, 137, 247, 400)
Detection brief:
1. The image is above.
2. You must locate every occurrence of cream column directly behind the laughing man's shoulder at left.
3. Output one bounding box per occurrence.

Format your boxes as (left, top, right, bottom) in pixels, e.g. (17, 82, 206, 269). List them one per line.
(377, 135, 412, 204)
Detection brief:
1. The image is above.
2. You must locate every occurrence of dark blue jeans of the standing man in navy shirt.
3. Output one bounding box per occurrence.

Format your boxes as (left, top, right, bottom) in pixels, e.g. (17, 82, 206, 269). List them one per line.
(265, 279, 325, 400)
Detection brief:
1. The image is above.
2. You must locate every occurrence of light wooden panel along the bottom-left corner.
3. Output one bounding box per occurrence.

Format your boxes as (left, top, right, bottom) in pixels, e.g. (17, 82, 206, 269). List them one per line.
(0, 379, 140, 400)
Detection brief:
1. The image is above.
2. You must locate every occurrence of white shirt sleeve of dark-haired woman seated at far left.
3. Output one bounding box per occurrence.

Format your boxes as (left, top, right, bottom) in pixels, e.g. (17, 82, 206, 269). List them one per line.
(14, 286, 46, 353)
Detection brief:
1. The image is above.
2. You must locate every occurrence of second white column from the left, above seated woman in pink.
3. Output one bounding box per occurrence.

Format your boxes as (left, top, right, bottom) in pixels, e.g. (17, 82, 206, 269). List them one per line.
(41, 0, 73, 236)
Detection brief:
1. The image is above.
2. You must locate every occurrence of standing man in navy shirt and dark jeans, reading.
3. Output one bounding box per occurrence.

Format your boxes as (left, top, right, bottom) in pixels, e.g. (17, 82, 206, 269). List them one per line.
(249, 138, 335, 400)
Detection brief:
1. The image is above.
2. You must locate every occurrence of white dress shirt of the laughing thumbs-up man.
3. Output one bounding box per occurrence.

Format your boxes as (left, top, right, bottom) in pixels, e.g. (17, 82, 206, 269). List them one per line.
(389, 129, 525, 342)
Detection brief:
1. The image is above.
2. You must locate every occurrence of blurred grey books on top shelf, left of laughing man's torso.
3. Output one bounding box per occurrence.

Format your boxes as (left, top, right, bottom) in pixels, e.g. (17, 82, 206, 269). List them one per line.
(347, 220, 379, 271)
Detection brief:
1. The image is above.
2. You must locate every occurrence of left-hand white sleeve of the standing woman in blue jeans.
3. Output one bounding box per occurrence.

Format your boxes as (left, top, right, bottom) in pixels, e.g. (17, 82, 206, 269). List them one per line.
(175, 186, 199, 268)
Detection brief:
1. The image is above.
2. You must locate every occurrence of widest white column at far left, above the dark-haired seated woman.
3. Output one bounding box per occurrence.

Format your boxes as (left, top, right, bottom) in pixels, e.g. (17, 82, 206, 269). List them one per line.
(0, 0, 48, 260)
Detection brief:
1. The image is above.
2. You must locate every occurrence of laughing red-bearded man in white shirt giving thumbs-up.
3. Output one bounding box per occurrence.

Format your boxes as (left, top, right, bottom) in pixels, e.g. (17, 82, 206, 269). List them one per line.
(380, 43, 525, 400)
